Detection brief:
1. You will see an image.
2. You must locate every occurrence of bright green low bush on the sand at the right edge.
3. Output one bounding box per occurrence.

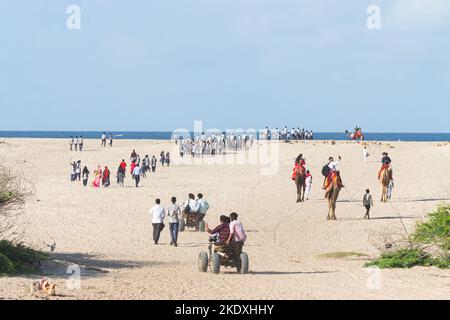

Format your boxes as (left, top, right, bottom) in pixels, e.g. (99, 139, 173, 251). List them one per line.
(365, 206, 450, 268)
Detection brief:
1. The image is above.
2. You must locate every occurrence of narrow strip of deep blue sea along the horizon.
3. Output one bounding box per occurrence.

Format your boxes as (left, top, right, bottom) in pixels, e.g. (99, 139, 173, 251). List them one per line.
(0, 131, 450, 141)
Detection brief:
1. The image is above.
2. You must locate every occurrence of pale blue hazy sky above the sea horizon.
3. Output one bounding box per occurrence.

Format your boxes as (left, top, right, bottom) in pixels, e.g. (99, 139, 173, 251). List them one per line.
(0, 0, 450, 132)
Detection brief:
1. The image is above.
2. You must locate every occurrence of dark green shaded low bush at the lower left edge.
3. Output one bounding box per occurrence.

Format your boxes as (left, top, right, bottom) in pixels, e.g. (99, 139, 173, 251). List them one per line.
(0, 240, 48, 275)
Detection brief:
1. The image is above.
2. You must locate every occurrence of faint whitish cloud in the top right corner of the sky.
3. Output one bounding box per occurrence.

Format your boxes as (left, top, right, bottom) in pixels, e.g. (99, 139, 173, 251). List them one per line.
(382, 0, 450, 31)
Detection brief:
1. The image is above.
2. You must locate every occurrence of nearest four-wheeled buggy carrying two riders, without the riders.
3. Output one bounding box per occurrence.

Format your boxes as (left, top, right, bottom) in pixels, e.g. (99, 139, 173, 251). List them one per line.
(198, 237, 248, 274)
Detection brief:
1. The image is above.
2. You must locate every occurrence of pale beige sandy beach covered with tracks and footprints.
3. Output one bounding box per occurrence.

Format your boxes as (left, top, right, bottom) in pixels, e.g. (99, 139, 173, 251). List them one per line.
(0, 139, 450, 299)
